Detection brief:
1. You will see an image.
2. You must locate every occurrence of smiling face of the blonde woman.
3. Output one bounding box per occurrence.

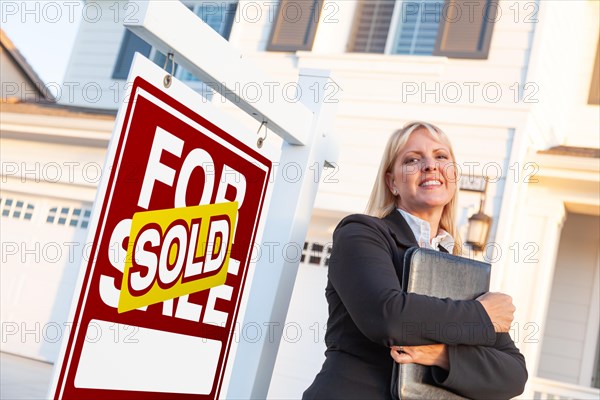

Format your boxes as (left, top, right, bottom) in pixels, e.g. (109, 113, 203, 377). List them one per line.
(387, 128, 457, 216)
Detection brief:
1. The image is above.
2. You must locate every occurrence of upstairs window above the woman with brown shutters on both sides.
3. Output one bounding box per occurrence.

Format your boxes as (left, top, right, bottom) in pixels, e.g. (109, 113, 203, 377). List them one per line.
(349, 0, 498, 59)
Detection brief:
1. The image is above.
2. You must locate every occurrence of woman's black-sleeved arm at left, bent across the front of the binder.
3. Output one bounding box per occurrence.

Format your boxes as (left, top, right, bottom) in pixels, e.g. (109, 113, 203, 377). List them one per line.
(329, 221, 496, 347)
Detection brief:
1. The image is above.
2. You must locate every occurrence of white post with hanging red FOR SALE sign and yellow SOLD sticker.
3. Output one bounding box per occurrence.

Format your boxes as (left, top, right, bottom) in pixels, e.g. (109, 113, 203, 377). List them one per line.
(51, 1, 336, 399)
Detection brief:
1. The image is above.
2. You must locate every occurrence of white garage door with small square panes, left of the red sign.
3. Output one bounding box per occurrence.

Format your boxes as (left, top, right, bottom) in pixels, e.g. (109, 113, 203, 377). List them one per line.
(0, 191, 91, 362)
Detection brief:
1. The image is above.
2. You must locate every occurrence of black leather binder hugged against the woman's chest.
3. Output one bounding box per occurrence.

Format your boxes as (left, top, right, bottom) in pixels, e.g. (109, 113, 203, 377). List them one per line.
(392, 247, 491, 400)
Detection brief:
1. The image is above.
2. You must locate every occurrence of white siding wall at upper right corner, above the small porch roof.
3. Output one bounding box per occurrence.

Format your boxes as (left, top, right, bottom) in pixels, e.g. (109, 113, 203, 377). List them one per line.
(527, 1, 600, 148)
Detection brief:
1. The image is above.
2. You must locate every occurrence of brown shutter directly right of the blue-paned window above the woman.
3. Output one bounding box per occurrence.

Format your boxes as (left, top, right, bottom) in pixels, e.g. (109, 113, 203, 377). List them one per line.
(433, 0, 499, 59)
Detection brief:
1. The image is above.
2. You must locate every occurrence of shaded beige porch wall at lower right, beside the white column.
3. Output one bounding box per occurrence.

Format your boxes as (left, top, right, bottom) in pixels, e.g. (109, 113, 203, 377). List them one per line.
(539, 214, 600, 386)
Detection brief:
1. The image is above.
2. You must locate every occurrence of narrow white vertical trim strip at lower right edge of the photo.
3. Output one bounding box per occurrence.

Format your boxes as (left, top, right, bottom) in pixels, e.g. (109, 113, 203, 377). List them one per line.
(579, 249, 600, 386)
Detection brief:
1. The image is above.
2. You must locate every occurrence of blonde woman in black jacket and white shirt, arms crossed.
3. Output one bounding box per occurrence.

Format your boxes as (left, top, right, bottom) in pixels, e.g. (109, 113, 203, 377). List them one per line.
(303, 122, 527, 399)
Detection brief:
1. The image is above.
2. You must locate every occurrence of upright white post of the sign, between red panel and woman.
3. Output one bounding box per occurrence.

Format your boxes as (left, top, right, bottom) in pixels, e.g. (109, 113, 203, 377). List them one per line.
(228, 70, 337, 399)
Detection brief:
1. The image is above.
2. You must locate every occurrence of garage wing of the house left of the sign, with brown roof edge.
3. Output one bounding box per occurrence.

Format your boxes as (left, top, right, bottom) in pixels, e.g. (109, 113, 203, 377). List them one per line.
(0, 27, 115, 362)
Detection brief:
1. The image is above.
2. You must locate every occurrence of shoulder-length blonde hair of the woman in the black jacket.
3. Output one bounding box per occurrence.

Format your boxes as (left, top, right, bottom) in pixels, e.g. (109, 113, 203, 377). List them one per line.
(366, 121, 462, 255)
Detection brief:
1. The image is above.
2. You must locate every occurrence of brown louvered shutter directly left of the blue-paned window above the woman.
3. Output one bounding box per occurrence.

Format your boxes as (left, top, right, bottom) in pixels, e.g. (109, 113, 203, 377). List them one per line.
(350, 0, 396, 53)
